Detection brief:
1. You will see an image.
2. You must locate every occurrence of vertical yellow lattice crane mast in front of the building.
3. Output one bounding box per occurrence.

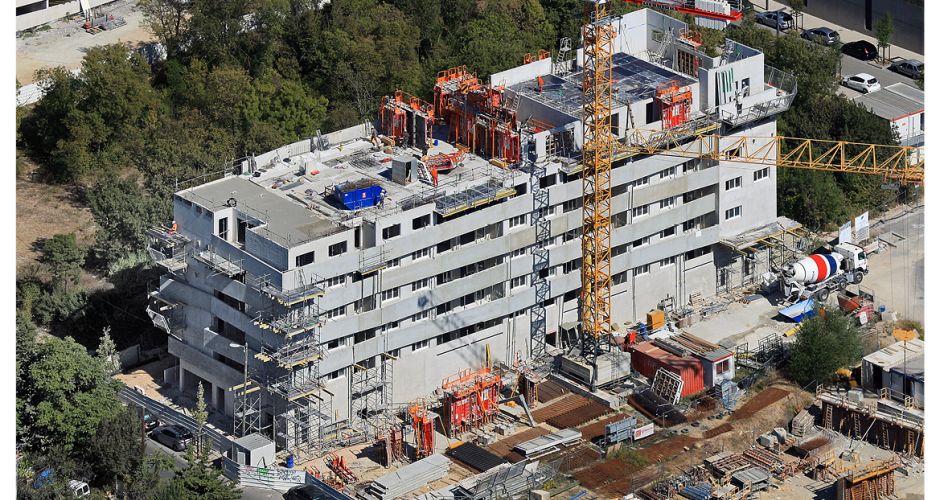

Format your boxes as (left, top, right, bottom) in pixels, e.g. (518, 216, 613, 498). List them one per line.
(581, 0, 615, 389)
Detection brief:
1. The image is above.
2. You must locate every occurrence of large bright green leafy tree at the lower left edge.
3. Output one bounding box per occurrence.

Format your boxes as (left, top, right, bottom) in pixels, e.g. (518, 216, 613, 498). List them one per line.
(16, 337, 122, 453)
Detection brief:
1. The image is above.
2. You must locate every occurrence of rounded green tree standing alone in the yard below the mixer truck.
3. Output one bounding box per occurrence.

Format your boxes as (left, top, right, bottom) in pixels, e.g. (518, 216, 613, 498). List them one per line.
(787, 308, 862, 387)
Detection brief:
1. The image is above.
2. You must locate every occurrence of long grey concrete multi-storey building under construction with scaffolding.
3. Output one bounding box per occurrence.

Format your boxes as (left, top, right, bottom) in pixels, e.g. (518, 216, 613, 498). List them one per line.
(149, 10, 796, 455)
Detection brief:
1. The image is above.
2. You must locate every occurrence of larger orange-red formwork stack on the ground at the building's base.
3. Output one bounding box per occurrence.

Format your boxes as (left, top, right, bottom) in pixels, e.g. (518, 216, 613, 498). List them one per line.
(441, 367, 502, 437)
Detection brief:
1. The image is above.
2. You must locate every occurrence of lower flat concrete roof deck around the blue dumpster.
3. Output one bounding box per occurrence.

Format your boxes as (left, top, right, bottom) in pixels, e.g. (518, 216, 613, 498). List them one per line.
(177, 138, 528, 248)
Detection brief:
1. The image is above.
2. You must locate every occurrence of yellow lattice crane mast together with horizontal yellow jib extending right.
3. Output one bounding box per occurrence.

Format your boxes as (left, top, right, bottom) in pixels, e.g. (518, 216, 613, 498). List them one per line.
(581, 0, 924, 390)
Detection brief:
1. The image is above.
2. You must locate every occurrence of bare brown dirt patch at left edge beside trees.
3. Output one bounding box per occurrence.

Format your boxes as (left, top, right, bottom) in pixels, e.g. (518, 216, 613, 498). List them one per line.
(16, 160, 95, 276)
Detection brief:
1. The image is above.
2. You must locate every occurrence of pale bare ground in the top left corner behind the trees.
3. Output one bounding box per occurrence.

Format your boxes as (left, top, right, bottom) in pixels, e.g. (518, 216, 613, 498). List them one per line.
(16, 0, 153, 85)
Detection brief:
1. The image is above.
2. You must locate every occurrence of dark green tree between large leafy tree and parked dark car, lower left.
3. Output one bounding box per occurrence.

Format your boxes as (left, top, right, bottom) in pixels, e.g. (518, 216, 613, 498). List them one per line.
(86, 407, 146, 486)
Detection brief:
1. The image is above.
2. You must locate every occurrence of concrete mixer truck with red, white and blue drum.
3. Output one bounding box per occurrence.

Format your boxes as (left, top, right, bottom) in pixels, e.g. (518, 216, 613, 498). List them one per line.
(779, 243, 868, 302)
